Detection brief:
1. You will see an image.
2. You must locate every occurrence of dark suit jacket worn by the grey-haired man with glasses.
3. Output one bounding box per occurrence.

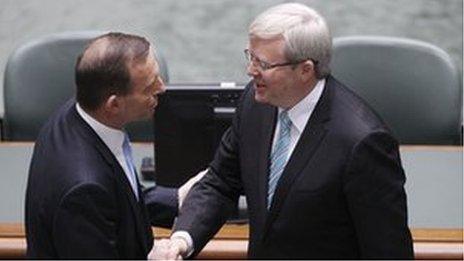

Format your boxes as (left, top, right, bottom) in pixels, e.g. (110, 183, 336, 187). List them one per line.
(175, 77, 413, 259)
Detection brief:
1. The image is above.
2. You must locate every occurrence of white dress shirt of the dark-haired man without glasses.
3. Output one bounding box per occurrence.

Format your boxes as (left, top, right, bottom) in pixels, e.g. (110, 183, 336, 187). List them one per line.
(76, 103, 139, 200)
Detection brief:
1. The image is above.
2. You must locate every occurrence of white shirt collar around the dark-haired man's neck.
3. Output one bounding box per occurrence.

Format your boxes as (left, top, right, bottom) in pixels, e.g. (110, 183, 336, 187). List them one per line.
(76, 103, 125, 155)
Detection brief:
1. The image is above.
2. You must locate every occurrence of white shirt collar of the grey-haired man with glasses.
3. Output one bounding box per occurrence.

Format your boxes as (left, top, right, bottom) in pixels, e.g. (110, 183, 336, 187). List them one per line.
(279, 79, 326, 133)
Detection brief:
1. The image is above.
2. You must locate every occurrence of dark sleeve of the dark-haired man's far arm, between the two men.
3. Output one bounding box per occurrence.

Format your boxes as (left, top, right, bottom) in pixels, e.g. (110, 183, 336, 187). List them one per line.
(144, 185, 179, 228)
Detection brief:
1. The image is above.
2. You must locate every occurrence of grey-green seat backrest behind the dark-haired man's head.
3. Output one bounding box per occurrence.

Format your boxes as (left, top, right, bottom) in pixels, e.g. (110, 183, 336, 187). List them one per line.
(3, 31, 168, 141)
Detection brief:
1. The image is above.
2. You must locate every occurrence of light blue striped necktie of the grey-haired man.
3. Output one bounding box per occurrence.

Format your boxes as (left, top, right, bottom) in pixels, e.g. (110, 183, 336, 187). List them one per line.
(267, 111, 292, 209)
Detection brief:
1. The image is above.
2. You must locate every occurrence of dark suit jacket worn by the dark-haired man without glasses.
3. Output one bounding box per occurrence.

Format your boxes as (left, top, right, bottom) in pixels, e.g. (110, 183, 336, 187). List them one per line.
(26, 100, 177, 259)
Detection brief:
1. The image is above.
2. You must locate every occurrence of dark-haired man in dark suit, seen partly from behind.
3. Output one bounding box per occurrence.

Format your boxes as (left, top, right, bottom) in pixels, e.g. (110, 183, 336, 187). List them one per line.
(26, 33, 199, 259)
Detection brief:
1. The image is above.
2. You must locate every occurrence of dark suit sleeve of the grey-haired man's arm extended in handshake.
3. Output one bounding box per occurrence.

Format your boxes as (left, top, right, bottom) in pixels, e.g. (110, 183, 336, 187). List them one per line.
(170, 85, 250, 256)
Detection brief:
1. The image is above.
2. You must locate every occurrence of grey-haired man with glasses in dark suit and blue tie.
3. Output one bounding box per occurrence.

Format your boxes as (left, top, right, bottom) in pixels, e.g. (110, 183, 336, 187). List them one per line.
(149, 3, 413, 259)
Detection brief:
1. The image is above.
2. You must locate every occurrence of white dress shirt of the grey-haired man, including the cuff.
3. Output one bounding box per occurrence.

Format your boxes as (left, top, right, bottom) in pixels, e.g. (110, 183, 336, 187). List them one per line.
(171, 79, 325, 257)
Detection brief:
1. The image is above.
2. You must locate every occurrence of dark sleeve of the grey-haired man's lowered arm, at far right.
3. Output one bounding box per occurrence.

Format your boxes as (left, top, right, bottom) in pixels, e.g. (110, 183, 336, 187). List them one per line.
(344, 132, 413, 259)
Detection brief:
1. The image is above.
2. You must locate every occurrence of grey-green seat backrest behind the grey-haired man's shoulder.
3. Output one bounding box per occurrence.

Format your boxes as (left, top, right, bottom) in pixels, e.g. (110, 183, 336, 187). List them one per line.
(331, 36, 462, 144)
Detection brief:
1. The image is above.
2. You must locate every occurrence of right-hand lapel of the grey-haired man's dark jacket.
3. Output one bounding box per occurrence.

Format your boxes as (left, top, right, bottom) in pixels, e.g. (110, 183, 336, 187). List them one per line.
(263, 81, 332, 238)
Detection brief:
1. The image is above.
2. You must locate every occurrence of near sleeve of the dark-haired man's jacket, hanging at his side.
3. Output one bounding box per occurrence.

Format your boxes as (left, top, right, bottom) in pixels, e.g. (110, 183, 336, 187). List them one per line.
(52, 184, 119, 259)
